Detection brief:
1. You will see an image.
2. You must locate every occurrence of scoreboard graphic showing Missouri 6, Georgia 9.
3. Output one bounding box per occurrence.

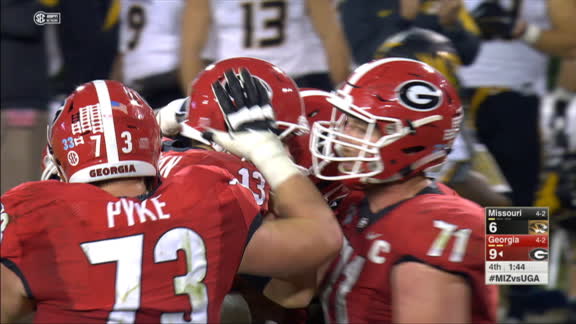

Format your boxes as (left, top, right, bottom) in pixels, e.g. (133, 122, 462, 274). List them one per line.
(484, 207, 550, 285)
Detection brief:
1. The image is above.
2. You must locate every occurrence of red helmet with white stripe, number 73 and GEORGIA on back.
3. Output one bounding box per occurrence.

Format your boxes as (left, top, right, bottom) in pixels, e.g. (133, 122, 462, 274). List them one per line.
(48, 80, 160, 183)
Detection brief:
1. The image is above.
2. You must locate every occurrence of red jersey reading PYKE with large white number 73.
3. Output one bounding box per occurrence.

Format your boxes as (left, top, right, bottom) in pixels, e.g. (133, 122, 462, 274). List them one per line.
(1, 166, 260, 323)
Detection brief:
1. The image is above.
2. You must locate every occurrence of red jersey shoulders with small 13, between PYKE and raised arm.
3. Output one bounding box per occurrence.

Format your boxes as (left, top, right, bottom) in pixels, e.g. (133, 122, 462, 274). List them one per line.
(158, 146, 270, 215)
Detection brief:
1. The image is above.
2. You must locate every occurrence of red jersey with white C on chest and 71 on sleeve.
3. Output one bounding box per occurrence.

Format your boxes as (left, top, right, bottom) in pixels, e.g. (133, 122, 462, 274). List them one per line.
(320, 184, 498, 323)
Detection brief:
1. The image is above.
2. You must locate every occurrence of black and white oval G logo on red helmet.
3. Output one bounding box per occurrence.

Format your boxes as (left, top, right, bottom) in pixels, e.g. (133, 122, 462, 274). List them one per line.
(397, 80, 442, 111)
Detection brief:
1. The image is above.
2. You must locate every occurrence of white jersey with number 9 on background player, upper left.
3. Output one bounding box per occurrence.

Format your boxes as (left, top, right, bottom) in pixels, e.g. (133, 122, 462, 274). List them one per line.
(119, 0, 185, 85)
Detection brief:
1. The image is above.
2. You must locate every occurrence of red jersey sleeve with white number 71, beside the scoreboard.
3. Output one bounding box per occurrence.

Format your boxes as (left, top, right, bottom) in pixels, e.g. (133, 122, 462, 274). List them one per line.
(397, 197, 484, 276)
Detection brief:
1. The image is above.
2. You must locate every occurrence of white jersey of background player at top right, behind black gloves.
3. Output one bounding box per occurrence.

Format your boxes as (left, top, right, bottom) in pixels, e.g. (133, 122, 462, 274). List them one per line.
(460, 0, 550, 94)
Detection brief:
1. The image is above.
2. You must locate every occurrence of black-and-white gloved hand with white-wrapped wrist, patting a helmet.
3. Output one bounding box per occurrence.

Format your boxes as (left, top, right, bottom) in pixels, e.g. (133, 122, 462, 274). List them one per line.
(204, 69, 299, 189)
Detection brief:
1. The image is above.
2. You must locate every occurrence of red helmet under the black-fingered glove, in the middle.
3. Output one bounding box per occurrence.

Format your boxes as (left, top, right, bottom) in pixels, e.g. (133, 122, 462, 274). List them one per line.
(181, 57, 309, 146)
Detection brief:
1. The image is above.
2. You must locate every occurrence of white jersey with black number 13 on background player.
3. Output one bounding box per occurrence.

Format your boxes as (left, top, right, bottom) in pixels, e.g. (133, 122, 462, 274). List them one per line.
(211, 0, 328, 77)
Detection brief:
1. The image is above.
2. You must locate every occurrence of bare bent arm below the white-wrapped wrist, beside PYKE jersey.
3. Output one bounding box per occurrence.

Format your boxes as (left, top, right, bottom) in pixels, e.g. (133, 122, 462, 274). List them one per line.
(240, 170, 342, 278)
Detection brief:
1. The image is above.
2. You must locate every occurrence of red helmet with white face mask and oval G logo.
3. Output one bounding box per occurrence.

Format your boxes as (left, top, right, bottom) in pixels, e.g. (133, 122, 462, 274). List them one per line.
(310, 58, 463, 185)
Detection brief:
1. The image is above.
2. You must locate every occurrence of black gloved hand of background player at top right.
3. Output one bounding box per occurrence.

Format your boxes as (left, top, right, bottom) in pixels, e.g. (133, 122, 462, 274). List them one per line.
(472, 1, 516, 40)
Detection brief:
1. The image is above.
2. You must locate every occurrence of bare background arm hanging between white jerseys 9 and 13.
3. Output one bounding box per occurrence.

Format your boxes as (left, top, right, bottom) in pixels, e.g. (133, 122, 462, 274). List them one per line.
(180, 0, 212, 94)
